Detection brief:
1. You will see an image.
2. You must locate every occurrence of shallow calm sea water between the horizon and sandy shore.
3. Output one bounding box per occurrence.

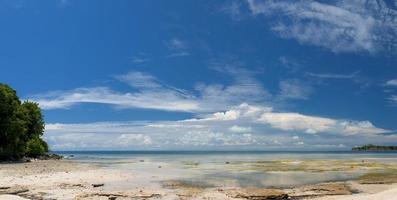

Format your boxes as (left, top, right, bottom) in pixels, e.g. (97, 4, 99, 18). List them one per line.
(55, 151, 397, 188)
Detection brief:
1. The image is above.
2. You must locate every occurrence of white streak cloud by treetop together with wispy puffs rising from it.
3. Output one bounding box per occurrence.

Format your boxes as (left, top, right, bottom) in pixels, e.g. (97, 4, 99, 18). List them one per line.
(28, 69, 268, 113)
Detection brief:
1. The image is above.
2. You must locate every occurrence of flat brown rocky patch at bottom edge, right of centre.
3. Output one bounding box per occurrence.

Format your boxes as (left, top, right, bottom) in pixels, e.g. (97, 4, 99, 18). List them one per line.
(224, 188, 288, 200)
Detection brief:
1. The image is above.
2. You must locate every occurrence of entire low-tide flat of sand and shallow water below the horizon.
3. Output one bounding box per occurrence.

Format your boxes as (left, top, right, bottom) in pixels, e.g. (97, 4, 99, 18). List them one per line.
(0, 153, 397, 199)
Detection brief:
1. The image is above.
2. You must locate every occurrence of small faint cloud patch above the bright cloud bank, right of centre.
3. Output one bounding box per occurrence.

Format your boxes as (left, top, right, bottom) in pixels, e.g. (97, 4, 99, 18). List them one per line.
(279, 79, 312, 99)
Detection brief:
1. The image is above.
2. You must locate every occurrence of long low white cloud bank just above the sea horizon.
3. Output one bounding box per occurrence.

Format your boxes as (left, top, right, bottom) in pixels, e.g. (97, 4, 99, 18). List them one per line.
(45, 103, 396, 150)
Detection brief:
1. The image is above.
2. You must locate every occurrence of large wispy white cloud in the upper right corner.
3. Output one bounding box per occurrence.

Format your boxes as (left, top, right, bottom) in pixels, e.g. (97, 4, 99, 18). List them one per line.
(247, 0, 397, 52)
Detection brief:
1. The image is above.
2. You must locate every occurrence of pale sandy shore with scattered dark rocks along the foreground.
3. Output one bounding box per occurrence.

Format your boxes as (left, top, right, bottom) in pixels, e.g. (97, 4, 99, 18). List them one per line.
(0, 160, 397, 200)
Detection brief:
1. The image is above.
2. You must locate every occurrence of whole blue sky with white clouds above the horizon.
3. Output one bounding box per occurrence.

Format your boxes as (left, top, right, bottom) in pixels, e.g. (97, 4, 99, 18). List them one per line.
(0, 0, 397, 150)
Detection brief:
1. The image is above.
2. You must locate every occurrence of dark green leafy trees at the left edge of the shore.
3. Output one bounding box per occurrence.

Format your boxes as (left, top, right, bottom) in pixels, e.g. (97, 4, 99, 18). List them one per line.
(0, 83, 48, 160)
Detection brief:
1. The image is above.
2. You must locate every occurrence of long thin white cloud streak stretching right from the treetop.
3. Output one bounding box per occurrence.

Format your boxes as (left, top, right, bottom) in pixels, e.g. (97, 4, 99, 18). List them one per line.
(29, 87, 199, 112)
